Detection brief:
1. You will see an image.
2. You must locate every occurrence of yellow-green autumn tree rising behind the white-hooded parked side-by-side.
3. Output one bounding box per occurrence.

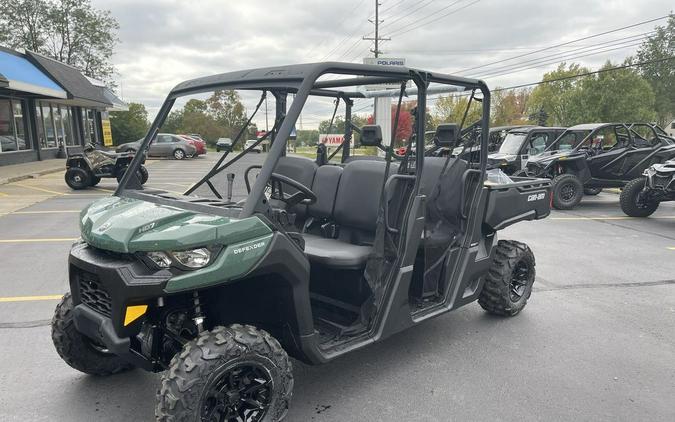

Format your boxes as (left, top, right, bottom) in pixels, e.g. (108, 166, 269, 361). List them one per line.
(528, 63, 589, 126)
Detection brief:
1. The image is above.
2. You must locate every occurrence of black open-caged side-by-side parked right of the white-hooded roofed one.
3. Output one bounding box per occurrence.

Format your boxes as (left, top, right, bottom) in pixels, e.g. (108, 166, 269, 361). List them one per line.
(526, 123, 675, 209)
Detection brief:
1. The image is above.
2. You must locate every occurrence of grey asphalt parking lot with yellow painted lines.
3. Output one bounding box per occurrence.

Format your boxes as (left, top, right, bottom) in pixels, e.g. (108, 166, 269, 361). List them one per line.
(0, 154, 675, 421)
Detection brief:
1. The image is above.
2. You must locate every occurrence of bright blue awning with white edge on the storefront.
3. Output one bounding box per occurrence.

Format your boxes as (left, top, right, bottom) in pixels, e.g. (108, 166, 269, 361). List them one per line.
(0, 50, 68, 98)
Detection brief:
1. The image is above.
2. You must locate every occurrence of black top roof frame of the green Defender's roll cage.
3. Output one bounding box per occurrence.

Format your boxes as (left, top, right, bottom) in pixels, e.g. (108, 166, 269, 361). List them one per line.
(171, 62, 487, 95)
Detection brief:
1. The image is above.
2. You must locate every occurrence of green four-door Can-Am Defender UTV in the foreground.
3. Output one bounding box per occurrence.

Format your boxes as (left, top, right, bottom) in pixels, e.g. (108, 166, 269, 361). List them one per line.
(52, 63, 550, 421)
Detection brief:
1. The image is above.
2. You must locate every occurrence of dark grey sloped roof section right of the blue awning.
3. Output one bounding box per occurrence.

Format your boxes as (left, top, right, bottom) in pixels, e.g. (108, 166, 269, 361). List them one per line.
(26, 51, 112, 107)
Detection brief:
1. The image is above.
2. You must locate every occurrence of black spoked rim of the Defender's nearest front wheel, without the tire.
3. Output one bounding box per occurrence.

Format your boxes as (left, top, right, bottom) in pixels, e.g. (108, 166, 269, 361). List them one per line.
(201, 362, 274, 422)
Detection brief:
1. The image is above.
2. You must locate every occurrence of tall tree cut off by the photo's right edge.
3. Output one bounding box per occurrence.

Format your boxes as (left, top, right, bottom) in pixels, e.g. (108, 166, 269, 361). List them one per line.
(637, 14, 675, 126)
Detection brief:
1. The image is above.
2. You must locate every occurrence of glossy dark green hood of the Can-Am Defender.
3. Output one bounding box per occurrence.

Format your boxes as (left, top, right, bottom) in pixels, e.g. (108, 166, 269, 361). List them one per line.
(80, 196, 271, 253)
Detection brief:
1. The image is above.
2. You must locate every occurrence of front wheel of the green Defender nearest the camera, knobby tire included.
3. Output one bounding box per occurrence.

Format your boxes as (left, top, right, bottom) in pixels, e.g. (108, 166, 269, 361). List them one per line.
(160, 324, 293, 422)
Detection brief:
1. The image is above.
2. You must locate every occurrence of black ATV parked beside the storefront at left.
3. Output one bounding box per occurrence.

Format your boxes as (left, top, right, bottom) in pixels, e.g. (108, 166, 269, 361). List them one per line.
(64, 144, 148, 190)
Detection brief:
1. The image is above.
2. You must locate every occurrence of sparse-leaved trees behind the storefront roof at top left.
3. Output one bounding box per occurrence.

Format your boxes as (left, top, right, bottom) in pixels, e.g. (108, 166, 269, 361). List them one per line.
(0, 0, 119, 85)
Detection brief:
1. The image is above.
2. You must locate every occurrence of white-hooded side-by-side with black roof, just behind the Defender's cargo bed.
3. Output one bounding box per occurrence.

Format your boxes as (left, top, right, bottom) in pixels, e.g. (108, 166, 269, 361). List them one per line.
(488, 126, 565, 174)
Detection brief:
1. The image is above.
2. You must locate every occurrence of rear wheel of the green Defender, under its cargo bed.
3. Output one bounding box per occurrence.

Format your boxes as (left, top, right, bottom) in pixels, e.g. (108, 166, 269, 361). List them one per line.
(478, 240, 536, 316)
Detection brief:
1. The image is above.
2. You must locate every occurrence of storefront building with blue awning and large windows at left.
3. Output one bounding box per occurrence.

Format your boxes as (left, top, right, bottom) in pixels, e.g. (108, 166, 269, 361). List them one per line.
(0, 47, 126, 166)
